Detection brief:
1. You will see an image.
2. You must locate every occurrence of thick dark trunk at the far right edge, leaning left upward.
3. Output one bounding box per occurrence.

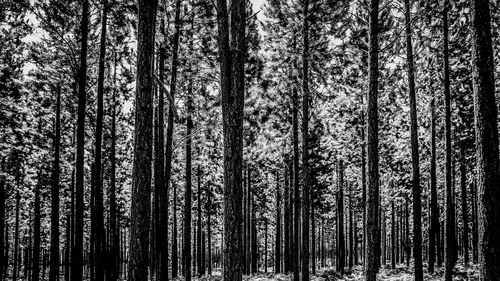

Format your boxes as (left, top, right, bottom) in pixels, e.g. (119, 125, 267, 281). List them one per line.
(472, 0, 500, 281)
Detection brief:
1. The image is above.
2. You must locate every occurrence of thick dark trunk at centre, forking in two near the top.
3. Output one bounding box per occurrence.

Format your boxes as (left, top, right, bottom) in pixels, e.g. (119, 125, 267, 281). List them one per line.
(217, 0, 246, 281)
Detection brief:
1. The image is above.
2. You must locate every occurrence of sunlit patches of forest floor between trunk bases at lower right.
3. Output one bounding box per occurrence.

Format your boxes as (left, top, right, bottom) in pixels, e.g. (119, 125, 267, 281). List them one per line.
(193, 263, 479, 281)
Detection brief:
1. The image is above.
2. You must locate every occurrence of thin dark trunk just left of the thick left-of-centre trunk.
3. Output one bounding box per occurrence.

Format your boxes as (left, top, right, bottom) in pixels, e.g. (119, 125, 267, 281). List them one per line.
(109, 48, 120, 281)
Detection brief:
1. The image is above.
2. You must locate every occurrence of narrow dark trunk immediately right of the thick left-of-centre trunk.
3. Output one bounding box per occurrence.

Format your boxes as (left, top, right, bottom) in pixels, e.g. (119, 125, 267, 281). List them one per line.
(154, 7, 168, 281)
